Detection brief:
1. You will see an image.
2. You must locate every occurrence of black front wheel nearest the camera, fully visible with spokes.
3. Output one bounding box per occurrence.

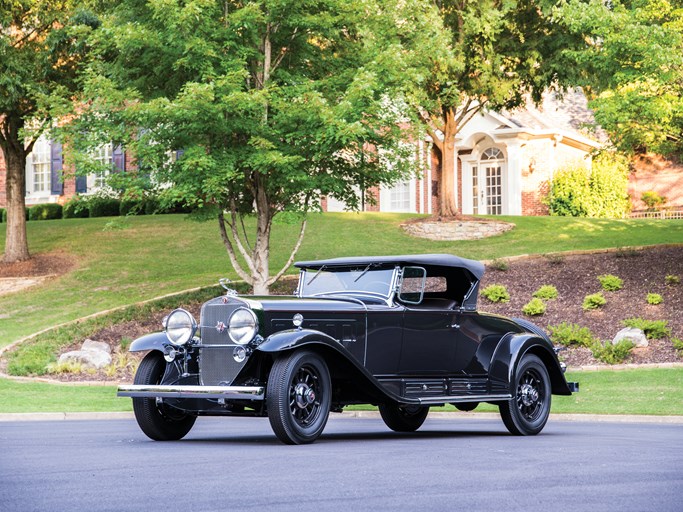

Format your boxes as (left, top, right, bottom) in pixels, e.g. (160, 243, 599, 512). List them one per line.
(266, 350, 332, 444)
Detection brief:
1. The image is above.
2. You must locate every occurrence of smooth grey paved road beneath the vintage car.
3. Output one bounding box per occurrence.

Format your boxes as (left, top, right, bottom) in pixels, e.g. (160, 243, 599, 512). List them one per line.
(0, 415, 683, 512)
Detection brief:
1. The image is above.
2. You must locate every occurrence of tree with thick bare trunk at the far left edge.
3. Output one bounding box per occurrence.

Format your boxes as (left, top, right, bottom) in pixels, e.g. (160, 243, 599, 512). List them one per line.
(0, 0, 97, 263)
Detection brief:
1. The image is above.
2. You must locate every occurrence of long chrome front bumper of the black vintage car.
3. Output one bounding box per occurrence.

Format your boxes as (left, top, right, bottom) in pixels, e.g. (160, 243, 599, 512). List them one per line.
(116, 384, 265, 400)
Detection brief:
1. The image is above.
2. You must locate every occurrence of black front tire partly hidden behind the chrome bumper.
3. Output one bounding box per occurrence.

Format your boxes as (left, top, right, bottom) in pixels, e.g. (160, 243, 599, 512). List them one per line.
(133, 352, 197, 441)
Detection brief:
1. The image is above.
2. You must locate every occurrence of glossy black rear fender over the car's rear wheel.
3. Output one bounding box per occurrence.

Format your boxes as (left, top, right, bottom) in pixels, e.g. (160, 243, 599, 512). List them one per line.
(489, 333, 572, 395)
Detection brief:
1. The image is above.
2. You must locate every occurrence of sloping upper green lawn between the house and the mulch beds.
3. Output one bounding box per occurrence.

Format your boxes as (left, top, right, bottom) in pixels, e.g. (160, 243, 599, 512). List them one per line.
(0, 213, 683, 347)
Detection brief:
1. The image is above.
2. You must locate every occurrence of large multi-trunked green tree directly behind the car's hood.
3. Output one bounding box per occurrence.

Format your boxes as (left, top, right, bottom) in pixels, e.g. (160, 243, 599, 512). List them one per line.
(71, 0, 415, 294)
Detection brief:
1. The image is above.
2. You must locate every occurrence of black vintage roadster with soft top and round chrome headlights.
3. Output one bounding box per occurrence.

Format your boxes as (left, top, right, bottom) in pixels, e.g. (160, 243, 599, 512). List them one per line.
(118, 254, 578, 444)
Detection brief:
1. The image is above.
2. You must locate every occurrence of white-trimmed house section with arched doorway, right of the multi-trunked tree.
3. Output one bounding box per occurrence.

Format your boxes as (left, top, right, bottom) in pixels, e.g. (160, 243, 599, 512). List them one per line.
(323, 92, 602, 215)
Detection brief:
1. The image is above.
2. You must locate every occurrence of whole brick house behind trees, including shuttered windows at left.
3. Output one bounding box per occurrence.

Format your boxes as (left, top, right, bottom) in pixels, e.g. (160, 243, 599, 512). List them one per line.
(5, 91, 683, 215)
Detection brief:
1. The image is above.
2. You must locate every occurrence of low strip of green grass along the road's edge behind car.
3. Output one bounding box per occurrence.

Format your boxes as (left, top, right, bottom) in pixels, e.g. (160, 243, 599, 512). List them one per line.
(0, 368, 683, 416)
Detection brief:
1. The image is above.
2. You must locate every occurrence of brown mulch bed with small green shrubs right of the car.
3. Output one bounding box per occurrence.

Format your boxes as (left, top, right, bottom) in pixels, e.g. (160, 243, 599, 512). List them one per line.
(479, 246, 683, 367)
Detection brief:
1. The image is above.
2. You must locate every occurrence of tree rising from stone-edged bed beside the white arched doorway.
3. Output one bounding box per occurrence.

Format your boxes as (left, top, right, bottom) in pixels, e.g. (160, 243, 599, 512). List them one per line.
(412, 0, 576, 216)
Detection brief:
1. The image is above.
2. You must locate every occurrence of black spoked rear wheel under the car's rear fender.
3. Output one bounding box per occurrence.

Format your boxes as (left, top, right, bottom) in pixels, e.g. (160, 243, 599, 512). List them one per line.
(500, 354, 551, 436)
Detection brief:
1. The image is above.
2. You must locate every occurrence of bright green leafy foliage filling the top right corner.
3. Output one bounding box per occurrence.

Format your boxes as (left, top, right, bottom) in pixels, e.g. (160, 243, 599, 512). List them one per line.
(557, 0, 683, 155)
